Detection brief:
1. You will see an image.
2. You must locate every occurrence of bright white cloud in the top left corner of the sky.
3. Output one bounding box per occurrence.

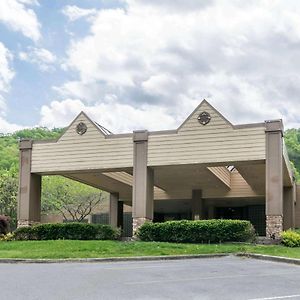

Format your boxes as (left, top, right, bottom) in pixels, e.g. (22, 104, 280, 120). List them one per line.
(0, 0, 41, 41)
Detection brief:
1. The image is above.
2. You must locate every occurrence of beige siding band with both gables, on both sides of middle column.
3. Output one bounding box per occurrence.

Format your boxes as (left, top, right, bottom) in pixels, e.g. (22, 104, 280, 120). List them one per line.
(32, 101, 265, 173)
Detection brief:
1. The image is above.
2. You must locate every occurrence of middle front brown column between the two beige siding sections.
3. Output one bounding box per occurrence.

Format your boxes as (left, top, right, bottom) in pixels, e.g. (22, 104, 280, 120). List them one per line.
(132, 130, 154, 235)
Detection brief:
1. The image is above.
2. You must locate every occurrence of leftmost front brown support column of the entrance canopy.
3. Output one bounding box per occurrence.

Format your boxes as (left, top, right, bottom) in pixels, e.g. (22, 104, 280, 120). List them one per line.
(18, 140, 41, 227)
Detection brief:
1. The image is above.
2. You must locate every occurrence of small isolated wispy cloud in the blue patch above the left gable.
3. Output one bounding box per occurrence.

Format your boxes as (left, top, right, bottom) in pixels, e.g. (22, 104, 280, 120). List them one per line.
(19, 47, 57, 71)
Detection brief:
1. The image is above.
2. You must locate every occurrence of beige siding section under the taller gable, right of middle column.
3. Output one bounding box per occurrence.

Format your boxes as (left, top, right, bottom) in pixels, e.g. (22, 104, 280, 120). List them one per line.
(148, 102, 265, 166)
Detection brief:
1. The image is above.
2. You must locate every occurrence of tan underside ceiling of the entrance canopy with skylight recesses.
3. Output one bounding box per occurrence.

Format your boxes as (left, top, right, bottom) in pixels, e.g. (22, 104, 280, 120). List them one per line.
(60, 165, 265, 202)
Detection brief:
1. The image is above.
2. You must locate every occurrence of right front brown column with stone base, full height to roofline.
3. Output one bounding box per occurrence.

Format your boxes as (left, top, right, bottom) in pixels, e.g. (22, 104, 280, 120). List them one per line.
(266, 120, 283, 239)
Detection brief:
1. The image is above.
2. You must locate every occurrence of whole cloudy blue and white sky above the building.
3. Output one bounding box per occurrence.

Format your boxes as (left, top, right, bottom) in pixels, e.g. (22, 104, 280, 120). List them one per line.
(0, 0, 300, 132)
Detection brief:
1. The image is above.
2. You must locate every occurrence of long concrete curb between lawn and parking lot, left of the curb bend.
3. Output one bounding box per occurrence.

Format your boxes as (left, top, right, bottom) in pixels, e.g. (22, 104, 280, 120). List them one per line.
(0, 253, 231, 264)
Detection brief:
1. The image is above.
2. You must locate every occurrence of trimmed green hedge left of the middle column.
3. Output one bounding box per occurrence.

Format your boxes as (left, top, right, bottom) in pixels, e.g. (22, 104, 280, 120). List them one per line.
(14, 223, 120, 240)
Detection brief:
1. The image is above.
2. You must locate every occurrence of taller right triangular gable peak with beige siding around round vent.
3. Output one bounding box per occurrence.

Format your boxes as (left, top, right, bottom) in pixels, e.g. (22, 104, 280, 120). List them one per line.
(177, 100, 233, 131)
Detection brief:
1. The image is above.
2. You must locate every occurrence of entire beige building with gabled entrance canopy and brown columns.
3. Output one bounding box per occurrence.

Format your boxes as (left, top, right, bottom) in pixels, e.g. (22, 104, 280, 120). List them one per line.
(18, 100, 300, 238)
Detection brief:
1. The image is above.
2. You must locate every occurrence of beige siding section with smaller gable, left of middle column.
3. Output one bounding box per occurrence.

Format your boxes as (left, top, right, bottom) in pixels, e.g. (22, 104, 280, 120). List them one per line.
(31, 114, 133, 173)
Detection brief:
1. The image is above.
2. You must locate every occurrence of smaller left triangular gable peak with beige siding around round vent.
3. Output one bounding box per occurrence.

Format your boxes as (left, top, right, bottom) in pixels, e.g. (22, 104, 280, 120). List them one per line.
(57, 111, 106, 142)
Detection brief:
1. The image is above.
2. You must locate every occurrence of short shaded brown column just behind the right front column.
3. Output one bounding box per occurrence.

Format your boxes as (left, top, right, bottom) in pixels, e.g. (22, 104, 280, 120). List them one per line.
(283, 183, 296, 230)
